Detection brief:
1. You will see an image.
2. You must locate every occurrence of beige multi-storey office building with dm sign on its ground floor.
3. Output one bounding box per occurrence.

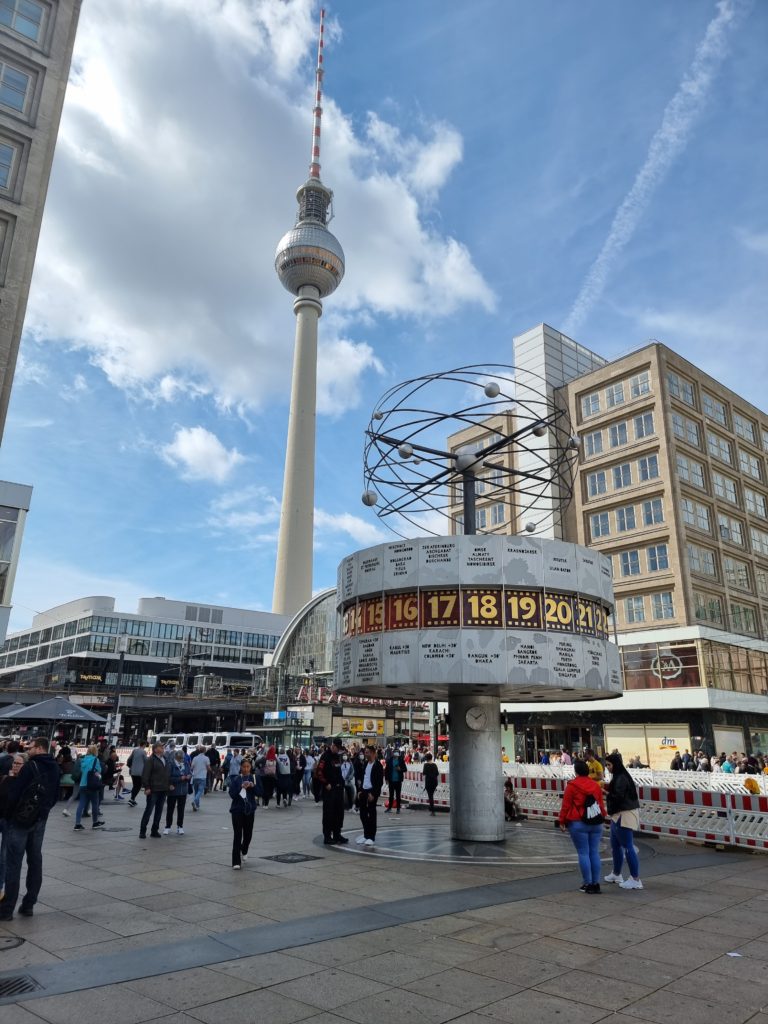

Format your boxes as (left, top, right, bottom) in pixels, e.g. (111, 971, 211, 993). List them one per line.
(450, 325, 768, 767)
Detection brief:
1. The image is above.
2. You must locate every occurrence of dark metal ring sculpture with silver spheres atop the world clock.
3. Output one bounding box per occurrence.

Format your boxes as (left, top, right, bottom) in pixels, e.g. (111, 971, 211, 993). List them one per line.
(362, 364, 579, 537)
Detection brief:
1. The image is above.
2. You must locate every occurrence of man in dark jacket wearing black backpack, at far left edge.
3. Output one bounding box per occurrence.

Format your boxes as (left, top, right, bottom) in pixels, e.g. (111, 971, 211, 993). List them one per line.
(0, 736, 60, 921)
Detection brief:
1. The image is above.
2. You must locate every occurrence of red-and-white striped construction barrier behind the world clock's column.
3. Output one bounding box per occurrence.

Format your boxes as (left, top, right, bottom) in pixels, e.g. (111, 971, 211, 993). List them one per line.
(402, 765, 768, 851)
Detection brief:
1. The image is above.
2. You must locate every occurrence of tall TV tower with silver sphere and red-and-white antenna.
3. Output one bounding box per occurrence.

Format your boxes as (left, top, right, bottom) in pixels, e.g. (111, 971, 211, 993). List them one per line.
(272, 10, 344, 615)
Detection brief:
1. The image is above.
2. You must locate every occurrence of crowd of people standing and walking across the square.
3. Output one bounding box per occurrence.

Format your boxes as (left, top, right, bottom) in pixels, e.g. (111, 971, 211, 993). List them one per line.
(0, 737, 768, 921)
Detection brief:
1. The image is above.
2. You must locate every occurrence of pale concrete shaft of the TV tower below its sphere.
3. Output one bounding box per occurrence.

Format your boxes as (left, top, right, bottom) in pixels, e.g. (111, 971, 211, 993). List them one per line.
(272, 285, 323, 615)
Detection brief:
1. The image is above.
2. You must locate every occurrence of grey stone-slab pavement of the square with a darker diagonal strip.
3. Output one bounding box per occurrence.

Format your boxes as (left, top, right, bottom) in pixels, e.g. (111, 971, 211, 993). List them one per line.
(0, 795, 768, 1024)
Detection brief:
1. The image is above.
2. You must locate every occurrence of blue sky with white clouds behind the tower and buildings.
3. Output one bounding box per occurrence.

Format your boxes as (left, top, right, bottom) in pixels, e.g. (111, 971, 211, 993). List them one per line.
(0, 0, 768, 629)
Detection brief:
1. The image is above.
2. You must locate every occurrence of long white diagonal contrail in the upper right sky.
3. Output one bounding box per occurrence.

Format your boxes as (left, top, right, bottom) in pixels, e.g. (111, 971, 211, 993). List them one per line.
(563, 0, 752, 336)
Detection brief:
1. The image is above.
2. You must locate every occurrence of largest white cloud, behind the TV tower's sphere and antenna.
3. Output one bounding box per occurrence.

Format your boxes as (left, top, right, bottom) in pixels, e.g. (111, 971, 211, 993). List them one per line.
(28, 0, 494, 414)
